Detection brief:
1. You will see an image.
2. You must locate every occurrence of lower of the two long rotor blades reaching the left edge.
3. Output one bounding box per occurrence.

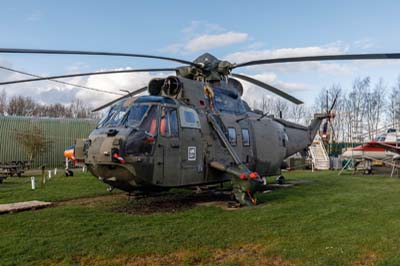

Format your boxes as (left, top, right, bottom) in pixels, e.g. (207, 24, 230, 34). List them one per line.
(0, 68, 175, 85)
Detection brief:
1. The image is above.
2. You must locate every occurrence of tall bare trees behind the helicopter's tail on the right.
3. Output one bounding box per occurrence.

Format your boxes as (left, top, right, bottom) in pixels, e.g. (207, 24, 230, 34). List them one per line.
(252, 77, 400, 142)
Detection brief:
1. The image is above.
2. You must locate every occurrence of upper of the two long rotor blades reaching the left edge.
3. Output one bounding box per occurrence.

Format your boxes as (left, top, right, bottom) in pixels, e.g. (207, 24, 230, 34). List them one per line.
(0, 48, 198, 66)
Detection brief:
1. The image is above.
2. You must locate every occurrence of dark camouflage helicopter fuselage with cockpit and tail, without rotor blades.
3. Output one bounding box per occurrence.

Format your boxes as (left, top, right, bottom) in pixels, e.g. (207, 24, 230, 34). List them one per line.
(75, 76, 325, 205)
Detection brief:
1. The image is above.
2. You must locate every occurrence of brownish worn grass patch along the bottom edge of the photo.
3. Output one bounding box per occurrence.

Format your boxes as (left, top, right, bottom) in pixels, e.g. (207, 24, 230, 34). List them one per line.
(41, 244, 296, 266)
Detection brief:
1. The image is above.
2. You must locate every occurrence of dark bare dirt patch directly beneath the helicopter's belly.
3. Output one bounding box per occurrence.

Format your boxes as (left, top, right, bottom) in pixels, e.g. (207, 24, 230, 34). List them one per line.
(113, 192, 231, 214)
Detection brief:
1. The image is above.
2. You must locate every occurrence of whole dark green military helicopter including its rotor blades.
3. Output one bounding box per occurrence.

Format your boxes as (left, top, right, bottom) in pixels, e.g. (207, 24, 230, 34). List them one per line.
(0, 48, 400, 206)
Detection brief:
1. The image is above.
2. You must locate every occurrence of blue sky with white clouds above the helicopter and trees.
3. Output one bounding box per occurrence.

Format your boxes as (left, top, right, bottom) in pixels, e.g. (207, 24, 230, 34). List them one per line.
(0, 0, 400, 106)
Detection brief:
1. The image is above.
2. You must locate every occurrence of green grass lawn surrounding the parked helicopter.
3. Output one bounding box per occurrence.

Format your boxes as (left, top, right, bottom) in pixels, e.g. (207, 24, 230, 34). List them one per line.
(0, 171, 400, 265)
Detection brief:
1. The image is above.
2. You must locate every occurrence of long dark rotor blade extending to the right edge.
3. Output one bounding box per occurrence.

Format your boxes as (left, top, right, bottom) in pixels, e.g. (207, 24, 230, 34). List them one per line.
(232, 53, 400, 69)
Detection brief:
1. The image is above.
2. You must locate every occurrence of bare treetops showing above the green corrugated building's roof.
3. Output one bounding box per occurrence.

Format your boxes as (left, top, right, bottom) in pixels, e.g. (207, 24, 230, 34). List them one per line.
(0, 89, 97, 118)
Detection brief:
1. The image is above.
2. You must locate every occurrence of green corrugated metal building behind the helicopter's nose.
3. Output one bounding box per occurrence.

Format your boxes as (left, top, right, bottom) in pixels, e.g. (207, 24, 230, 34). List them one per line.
(0, 116, 96, 167)
